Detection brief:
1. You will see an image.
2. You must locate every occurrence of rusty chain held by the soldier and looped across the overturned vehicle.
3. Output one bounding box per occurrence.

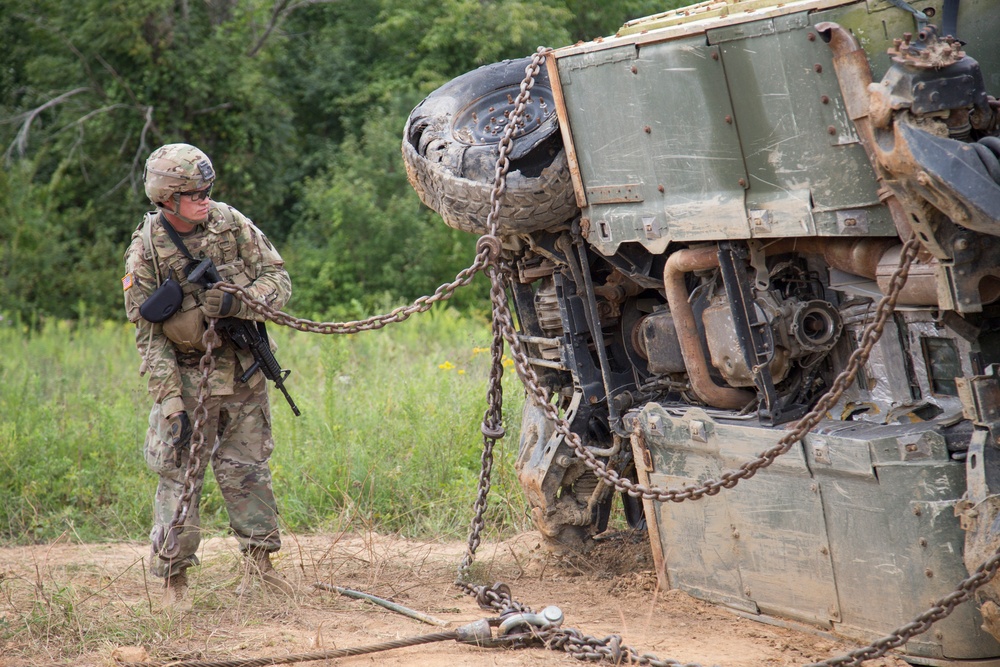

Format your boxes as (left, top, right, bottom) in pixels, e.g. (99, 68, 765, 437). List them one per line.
(154, 48, 1000, 667)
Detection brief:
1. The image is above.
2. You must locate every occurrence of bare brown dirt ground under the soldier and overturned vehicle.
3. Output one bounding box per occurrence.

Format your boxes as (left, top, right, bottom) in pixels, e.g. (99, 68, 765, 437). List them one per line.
(0, 533, 906, 667)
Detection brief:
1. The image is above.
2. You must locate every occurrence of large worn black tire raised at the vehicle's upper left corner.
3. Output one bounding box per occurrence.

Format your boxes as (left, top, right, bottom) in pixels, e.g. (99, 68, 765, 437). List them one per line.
(403, 58, 579, 234)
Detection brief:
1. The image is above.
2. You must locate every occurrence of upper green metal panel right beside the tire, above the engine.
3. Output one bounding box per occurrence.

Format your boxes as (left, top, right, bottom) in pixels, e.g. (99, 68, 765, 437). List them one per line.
(557, 36, 749, 254)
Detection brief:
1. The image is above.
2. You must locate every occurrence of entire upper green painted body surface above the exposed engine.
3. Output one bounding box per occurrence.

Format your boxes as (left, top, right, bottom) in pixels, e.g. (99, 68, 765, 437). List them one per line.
(556, 0, 1000, 254)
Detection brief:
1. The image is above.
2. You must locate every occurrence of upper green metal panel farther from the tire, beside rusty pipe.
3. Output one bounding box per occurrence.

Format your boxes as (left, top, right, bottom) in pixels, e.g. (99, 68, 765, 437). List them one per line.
(708, 13, 895, 238)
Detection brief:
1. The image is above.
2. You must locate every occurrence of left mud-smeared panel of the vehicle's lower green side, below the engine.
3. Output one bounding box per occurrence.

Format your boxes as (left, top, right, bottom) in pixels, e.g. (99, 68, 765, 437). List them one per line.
(640, 404, 840, 627)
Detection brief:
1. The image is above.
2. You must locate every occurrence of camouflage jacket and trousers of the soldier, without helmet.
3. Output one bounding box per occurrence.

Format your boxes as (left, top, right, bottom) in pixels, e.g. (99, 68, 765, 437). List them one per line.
(122, 201, 291, 577)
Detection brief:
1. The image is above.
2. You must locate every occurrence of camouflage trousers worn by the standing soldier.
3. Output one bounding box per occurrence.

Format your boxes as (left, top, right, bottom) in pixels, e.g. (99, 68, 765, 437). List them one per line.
(144, 382, 281, 577)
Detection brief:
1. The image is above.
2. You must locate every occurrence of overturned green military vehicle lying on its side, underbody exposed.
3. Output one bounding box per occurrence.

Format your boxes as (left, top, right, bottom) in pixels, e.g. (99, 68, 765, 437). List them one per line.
(403, 0, 1000, 665)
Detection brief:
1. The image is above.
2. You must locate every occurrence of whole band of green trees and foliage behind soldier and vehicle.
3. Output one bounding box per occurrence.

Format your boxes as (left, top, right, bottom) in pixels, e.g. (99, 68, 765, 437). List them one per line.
(0, 0, 676, 322)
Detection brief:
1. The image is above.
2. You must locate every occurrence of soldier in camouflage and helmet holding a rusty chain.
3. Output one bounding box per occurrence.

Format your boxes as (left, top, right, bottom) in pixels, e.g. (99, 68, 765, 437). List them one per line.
(122, 144, 292, 605)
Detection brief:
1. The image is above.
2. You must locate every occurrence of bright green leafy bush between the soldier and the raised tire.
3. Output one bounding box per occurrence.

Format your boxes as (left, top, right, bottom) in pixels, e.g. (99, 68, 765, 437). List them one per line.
(283, 98, 488, 316)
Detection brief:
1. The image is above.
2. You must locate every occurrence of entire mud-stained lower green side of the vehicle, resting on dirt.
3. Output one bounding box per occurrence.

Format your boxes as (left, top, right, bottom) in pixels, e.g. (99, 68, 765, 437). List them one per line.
(638, 403, 1000, 660)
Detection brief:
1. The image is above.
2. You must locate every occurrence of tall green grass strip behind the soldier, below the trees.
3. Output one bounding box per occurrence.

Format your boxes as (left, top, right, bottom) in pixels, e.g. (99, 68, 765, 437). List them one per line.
(0, 306, 527, 544)
